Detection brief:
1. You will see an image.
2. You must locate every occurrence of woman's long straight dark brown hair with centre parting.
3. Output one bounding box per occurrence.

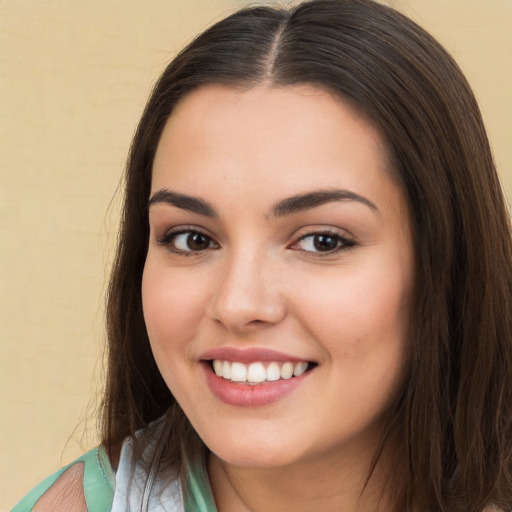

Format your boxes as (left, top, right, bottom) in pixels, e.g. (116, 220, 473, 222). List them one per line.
(102, 0, 512, 512)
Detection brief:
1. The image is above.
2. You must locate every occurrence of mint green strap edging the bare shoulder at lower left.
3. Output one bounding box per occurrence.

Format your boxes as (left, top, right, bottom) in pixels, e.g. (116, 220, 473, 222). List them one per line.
(11, 446, 115, 512)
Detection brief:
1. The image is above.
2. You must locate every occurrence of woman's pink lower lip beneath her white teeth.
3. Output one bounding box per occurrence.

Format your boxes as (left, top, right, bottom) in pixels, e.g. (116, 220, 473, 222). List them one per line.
(203, 364, 314, 407)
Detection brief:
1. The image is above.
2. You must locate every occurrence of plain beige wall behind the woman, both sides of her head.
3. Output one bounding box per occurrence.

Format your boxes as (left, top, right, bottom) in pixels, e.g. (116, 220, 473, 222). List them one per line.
(0, 0, 512, 511)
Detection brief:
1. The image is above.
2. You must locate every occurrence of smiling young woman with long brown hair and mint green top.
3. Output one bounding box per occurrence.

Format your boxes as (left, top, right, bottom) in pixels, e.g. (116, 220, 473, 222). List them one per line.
(15, 0, 512, 512)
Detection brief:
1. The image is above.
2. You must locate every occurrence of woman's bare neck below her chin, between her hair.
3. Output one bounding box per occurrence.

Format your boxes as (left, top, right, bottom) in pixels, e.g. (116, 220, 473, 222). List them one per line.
(209, 438, 390, 512)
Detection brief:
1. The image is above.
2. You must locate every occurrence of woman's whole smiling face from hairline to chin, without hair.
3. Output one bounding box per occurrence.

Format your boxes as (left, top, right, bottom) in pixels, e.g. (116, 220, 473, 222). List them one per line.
(142, 86, 413, 467)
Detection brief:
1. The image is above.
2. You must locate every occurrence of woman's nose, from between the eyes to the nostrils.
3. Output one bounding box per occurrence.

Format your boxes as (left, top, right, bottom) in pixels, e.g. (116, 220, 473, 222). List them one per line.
(210, 251, 286, 335)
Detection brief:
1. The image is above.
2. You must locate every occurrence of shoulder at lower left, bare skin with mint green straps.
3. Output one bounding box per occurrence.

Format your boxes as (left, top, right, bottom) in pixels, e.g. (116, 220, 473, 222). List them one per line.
(12, 448, 115, 512)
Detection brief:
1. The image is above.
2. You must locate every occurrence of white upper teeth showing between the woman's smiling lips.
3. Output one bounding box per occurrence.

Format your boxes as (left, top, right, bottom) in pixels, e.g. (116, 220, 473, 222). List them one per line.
(209, 359, 316, 385)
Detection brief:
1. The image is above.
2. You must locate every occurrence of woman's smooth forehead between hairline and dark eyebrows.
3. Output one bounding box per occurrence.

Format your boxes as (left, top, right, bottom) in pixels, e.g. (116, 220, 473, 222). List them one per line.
(152, 85, 398, 209)
